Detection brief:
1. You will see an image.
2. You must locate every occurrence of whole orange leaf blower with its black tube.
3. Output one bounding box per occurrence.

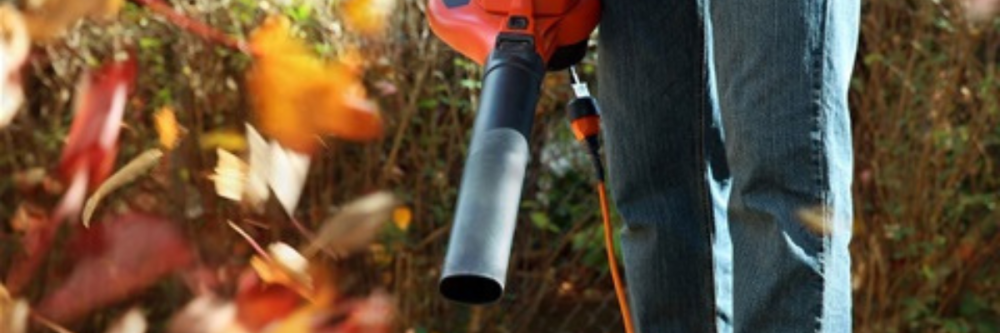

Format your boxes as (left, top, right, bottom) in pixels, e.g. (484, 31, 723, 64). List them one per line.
(427, 0, 600, 304)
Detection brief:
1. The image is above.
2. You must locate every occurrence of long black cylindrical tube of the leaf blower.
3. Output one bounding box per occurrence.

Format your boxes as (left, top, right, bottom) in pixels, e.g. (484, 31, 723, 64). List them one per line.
(439, 35, 545, 304)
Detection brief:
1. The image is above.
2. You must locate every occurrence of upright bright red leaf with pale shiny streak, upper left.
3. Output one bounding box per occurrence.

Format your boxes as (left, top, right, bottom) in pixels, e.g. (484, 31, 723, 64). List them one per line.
(59, 56, 138, 190)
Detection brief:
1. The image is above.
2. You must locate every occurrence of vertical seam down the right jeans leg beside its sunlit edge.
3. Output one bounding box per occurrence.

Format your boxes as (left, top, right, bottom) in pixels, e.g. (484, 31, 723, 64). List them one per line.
(811, 0, 831, 332)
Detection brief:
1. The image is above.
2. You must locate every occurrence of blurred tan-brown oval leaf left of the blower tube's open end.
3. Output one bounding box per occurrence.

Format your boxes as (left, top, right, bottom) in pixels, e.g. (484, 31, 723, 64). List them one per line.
(302, 192, 396, 257)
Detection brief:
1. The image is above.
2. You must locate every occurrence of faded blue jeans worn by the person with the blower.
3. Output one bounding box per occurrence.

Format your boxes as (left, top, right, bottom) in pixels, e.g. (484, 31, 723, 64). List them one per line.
(598, 0, 860, 333)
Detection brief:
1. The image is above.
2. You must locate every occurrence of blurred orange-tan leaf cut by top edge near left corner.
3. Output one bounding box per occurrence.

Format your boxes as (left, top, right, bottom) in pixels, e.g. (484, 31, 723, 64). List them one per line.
(25, 0, 124, 41)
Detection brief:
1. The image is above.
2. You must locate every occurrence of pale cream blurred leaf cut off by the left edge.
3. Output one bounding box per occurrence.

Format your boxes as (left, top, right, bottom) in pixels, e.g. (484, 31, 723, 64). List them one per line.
(0, 3, 31, 128)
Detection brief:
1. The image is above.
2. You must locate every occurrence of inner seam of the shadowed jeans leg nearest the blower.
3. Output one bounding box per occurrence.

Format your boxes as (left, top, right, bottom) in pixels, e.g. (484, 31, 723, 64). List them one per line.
(695, 4, 719, 332)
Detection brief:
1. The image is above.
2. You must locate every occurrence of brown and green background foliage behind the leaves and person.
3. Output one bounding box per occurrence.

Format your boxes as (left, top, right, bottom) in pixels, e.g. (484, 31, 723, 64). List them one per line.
(0, 0, 1000, 333)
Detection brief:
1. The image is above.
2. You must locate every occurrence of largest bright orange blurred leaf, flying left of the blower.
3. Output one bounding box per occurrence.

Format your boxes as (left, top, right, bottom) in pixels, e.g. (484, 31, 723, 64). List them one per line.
(247, 17, 382, 154)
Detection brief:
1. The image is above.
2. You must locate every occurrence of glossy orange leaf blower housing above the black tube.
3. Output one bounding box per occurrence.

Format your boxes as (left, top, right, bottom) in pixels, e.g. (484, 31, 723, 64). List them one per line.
(428, 0, 601, 70)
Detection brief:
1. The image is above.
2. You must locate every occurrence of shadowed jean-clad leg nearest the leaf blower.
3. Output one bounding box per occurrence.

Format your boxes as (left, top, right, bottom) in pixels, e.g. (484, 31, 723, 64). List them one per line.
(598, 0, 731, 333)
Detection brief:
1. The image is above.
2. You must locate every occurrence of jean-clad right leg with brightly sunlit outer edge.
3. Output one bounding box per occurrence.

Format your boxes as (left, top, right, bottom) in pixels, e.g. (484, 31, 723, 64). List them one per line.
(711, 0, 860, 332)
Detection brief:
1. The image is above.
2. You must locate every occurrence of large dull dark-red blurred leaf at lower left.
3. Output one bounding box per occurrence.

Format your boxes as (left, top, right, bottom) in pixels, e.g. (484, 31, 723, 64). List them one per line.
(38, 214, 192, 323)
